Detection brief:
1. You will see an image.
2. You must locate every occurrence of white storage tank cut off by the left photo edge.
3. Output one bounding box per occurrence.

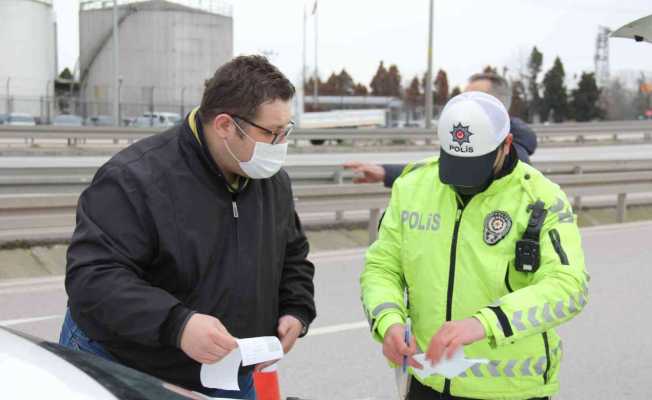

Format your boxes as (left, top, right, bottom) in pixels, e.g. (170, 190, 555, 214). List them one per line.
(0, 0, 57, 119)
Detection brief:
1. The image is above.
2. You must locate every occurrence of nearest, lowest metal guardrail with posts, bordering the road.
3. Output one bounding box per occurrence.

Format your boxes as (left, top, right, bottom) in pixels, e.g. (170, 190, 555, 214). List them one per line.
(0, 171, 652, 242)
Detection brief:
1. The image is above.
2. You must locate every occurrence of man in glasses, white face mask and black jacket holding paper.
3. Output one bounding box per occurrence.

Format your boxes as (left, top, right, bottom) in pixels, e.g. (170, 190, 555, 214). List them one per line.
(60, 56, 315, 399)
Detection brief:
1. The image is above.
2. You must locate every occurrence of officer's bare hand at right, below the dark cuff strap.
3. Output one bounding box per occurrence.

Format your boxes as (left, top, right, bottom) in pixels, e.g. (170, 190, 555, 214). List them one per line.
(426, 317, 486, 365)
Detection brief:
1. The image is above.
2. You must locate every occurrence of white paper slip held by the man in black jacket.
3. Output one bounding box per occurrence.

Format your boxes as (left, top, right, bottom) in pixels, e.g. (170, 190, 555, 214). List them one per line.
(199, 336, 283, 390)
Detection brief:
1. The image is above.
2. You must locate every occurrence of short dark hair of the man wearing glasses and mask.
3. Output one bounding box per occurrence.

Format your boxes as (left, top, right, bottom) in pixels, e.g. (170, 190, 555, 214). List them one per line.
(199, 55, 294, 123)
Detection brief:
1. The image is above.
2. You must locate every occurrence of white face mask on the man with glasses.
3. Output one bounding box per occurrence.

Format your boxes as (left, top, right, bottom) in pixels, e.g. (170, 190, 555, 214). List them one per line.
(224, 123, 288, 179)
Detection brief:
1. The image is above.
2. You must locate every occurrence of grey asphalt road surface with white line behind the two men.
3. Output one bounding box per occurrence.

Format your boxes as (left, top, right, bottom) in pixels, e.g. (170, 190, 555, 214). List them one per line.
(0, 223, 652, 400)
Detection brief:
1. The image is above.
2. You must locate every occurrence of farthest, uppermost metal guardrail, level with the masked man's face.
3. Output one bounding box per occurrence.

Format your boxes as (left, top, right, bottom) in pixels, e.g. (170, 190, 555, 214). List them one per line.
(0, 121, 652, 146)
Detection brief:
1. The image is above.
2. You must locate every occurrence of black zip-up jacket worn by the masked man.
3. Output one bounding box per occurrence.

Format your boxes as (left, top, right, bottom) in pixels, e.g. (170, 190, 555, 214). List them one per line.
(66, 113, 315, 390)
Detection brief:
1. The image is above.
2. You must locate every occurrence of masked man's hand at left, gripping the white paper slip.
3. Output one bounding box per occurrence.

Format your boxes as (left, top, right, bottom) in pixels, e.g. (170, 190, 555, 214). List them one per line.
(181, 314, 238, 364)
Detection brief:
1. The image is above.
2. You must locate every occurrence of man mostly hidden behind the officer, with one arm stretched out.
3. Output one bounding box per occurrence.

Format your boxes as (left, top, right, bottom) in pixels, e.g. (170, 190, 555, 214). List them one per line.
(344, 73, 537, 188)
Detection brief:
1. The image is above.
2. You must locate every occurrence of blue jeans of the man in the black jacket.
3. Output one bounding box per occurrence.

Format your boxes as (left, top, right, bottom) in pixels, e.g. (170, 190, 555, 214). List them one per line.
(59, 309, 256, 400)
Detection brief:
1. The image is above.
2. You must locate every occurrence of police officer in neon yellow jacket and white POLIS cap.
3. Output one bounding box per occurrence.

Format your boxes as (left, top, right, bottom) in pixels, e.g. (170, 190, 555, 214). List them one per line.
(361, 92, 588, 399)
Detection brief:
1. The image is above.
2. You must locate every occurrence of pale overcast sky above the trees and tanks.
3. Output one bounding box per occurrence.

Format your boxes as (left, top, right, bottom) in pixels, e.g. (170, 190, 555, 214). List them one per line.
(54, 0, 652, 88)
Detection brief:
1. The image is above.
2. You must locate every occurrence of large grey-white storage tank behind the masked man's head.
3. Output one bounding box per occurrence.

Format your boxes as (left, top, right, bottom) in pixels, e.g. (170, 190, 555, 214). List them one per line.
(79, 0, 233, 120)
